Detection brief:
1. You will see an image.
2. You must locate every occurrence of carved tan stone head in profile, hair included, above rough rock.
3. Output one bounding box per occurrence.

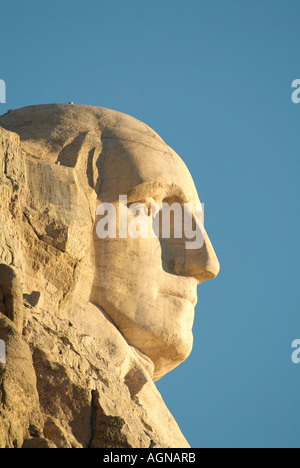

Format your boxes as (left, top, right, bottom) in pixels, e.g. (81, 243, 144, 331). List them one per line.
(0, 105, 219, 379)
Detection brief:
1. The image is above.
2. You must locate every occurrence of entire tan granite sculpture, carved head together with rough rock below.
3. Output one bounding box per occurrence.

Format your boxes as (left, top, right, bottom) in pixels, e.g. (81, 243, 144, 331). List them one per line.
(0, 105, 219, 448)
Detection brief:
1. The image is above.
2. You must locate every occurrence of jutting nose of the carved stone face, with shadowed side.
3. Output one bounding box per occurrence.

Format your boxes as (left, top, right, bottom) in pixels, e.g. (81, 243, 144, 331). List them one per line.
(173, 231, 220, 284)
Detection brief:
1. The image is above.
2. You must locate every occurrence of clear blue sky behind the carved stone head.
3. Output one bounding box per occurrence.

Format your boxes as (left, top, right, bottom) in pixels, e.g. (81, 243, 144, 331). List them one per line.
(0, 0, 300, 447)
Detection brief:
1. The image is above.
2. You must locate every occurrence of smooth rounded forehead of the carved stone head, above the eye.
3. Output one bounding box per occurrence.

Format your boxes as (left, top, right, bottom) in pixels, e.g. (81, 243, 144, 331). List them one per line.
(98, 139, 199, 203)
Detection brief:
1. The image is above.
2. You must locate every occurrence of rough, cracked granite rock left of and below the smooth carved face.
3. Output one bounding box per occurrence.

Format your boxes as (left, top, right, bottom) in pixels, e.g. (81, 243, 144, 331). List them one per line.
(0, 110, 188, 448)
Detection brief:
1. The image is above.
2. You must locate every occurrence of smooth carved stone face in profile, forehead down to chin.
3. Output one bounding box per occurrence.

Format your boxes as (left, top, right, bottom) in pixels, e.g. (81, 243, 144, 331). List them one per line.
(92, 135, 219, 379)
